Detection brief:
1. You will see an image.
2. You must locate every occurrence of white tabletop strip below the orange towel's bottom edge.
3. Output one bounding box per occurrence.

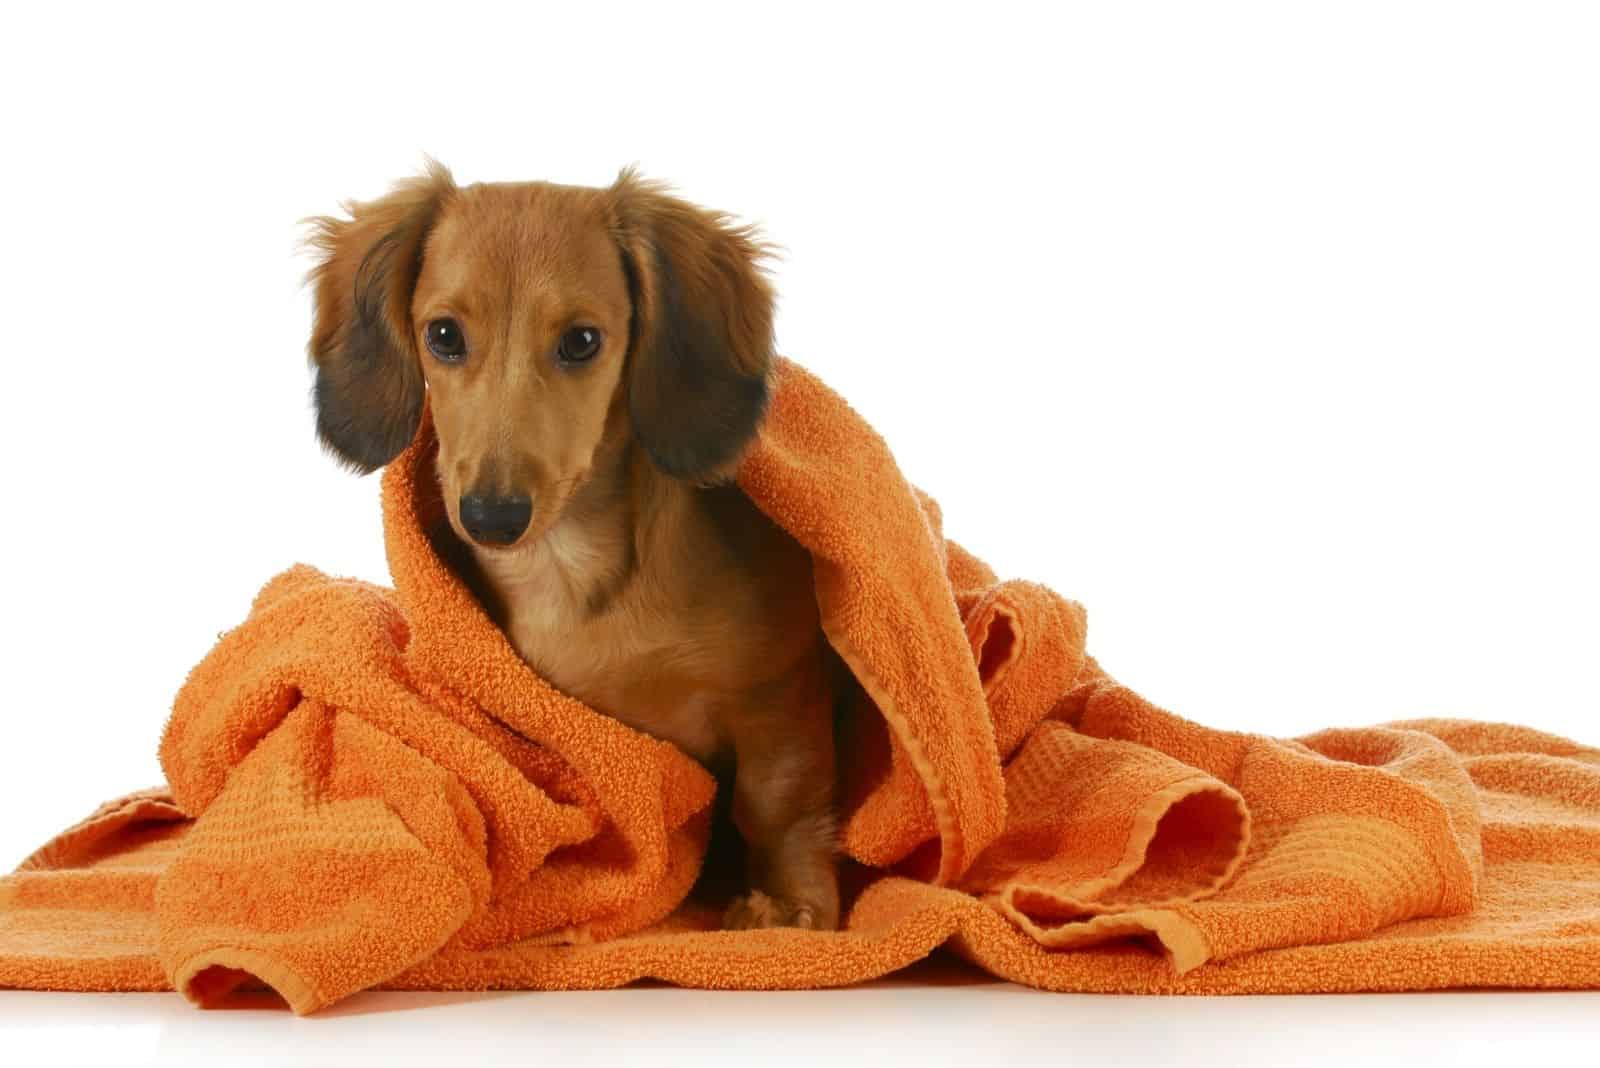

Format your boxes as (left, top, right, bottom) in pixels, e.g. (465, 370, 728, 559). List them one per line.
(0, 972, 1600, 1068)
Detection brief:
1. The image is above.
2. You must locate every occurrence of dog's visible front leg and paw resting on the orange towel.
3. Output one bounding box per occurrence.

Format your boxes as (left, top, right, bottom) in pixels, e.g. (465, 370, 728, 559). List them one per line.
(723, 681, 838, 931)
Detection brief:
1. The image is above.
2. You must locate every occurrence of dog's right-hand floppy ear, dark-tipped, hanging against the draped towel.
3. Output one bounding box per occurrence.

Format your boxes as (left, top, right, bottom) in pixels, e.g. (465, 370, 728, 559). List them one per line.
(610, 169, 773, 481)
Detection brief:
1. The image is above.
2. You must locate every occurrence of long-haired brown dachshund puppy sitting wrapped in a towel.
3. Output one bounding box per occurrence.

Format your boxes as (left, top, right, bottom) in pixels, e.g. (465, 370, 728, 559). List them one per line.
(310, 165, 843, 927)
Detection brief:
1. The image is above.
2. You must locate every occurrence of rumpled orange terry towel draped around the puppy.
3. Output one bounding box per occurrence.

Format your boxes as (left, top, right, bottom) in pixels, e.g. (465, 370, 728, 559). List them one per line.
(0, 365, 1600, 1012)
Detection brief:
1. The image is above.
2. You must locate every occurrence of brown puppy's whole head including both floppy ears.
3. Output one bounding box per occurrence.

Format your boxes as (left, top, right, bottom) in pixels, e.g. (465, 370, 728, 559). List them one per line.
(310, 165, 773, 547)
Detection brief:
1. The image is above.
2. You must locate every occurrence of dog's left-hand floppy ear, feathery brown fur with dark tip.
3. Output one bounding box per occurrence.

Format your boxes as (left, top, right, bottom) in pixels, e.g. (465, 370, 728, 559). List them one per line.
(307, 160, 456, 473)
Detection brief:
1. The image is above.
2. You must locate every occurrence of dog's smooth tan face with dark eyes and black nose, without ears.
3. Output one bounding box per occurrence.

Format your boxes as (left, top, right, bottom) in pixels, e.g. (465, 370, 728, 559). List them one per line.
(411, 185, 632, 545)
